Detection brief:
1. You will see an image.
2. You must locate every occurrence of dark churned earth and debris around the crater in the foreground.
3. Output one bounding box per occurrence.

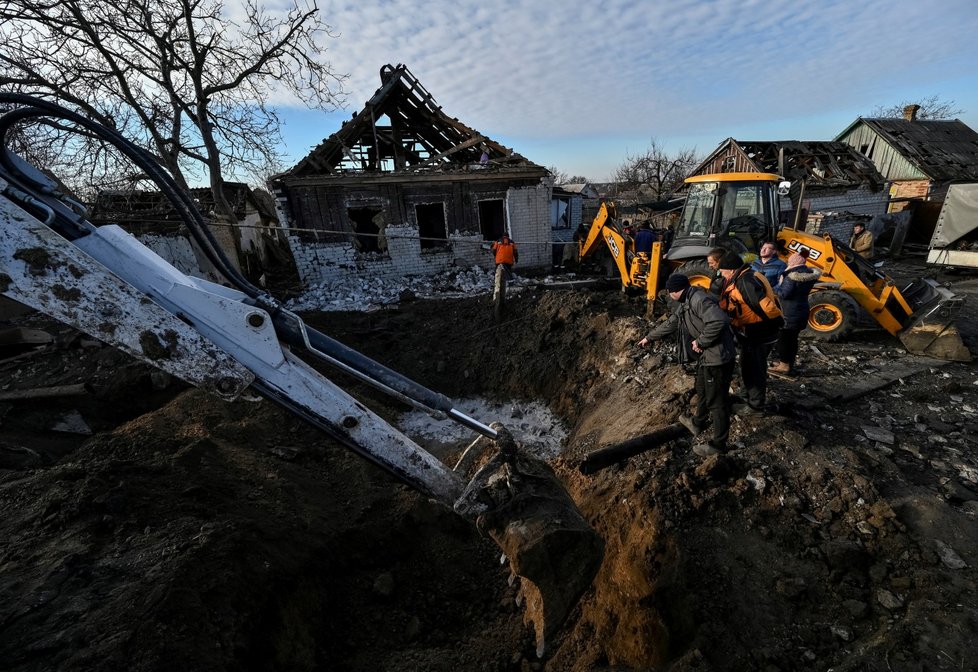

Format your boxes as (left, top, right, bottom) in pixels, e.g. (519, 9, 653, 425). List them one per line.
(0, 282, 978, 671)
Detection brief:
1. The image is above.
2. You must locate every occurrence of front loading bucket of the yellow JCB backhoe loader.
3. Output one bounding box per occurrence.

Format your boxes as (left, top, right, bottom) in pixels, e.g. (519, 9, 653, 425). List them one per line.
(897, 278, 971, 362)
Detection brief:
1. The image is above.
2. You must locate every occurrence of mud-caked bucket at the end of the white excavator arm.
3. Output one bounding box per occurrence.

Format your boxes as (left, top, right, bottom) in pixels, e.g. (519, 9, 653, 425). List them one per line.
(455, 423, 604, 657)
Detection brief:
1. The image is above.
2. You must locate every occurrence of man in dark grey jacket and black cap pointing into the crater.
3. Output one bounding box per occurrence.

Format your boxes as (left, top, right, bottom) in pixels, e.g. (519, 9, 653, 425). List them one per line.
(638, 273, 736, 457)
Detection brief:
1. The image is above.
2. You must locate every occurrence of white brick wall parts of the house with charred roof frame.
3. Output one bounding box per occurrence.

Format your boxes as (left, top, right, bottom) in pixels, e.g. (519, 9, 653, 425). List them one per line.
(279, 185, 551, 287)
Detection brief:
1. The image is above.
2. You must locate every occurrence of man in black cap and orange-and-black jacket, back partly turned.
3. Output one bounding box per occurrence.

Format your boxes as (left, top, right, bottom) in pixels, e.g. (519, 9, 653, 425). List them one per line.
(720, 251, 784, 414)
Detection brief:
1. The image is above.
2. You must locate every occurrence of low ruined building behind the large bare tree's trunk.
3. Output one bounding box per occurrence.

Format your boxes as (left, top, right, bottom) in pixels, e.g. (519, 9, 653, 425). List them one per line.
(90, 182, 282, 284)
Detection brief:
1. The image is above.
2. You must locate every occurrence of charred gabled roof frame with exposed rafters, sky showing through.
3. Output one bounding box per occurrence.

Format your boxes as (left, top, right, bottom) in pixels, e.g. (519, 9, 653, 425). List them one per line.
(288, 64, 546, 177)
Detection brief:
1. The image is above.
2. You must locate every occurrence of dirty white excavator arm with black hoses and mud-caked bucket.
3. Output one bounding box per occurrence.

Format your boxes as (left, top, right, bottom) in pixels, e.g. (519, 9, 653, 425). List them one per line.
(0, 94, 603, 654)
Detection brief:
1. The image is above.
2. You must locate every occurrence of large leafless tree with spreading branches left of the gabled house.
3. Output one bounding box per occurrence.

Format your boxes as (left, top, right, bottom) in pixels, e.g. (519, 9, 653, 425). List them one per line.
(0, 0, 345, 216)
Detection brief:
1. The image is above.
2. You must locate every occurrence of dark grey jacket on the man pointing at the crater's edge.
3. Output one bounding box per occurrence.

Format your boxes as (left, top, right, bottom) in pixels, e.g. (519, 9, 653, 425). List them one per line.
(647, 287, 737, 366)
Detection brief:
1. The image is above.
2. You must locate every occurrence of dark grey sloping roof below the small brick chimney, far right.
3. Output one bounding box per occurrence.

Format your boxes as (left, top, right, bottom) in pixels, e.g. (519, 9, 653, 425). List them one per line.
(836, 117, 978, 182)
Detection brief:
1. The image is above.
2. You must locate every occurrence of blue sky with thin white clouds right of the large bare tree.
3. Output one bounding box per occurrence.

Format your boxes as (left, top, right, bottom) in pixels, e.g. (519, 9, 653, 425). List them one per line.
(273, 0, 978, 181)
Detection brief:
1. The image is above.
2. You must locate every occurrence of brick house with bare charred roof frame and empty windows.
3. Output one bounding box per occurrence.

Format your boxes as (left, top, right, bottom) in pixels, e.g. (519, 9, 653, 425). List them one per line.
(272, 60, 553, 286)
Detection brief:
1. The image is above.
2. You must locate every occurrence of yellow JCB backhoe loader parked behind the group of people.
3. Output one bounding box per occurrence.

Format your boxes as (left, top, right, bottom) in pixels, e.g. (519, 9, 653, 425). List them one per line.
(608, 173, 971, 361)
